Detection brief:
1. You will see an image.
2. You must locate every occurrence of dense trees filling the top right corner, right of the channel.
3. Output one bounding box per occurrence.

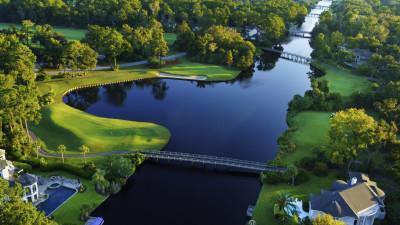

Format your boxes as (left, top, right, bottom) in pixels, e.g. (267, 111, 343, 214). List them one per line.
(311, 0, 400, 80)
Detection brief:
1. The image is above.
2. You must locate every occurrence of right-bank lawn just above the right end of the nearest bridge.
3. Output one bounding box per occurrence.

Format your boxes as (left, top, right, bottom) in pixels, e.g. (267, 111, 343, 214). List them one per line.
(283, 111, 331, 164)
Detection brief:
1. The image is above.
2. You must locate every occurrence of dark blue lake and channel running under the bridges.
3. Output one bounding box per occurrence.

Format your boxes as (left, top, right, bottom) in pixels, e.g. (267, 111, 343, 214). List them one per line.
(63, 1, 330, 225)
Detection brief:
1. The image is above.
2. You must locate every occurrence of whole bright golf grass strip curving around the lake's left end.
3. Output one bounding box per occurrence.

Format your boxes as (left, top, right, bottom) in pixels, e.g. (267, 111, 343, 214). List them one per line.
(30, 58, 240, 154)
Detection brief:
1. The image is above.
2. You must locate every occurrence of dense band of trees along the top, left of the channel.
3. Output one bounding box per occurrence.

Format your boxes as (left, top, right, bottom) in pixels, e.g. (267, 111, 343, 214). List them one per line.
(0, 0, 310, 44)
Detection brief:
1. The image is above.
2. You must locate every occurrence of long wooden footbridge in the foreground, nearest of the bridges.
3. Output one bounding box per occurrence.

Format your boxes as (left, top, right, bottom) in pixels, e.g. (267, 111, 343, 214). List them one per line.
(138, 150, 285, 173)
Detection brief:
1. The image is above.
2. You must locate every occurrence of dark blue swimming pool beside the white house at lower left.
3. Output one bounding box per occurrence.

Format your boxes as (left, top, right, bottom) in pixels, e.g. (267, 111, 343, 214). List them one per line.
(36, 186, 76, 216)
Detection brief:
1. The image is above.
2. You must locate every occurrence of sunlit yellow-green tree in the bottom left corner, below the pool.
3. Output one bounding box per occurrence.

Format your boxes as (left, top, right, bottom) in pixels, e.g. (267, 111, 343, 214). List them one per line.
(0, 178, 56, 225)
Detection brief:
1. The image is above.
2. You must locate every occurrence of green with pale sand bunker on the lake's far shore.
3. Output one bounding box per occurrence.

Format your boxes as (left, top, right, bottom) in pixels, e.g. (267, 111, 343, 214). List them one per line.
(160, 57, 240, 81)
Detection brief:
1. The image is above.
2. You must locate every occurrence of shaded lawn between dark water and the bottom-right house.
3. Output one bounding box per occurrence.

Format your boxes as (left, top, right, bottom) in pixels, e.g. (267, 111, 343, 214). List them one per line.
(252, 172, 337, 225)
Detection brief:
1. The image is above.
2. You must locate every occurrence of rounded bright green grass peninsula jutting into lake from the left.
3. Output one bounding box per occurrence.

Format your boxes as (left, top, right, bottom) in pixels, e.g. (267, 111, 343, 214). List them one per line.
(31, 103, 171, 154)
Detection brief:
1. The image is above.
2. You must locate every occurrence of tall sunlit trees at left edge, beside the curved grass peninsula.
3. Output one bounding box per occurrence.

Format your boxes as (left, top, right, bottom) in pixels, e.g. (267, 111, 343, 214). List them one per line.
(0, 34, 51, 159)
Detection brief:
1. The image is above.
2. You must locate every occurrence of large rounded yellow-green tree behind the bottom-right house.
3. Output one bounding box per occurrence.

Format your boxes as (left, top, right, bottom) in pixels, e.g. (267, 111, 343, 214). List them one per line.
(328, 108, 378, 172)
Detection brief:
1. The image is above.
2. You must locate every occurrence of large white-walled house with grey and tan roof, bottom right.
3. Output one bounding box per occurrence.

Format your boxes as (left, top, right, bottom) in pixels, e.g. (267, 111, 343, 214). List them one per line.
(310, 172, 386, 225)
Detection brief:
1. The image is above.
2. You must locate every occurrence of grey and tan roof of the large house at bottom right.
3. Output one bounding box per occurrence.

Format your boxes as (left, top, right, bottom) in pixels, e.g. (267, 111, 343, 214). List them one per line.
(310, 173, 385, 217)
